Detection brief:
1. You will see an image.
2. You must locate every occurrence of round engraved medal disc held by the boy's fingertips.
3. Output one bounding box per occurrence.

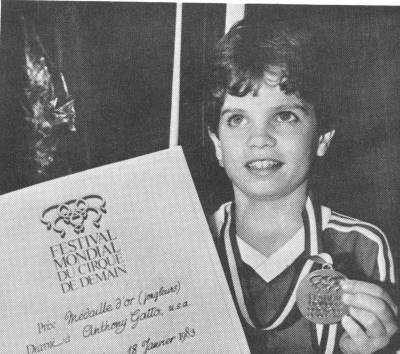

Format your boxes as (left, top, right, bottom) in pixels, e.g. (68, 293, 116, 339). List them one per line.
(296, 269, 349, 324)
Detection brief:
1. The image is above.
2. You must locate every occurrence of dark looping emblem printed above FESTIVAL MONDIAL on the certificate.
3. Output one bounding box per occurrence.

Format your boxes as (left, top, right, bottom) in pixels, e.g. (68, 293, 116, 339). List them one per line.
(40, 195, 107, 238)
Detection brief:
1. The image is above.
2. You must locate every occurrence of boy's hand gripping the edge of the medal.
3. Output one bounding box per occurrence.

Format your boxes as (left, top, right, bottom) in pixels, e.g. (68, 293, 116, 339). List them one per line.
(339, 280, 398, 354)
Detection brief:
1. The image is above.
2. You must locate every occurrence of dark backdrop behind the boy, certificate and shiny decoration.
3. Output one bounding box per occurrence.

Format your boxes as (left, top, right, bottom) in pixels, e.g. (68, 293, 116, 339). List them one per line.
(0, 1, 400, 276)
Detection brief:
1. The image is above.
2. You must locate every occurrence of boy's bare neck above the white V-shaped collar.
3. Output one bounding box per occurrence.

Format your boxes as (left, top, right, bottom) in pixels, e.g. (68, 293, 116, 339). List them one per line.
(235, 184, 307, 257)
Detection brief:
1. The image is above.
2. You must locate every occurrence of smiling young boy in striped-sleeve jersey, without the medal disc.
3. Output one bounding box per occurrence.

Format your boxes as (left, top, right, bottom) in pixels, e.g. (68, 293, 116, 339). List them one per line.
(209, 20, 398, 354)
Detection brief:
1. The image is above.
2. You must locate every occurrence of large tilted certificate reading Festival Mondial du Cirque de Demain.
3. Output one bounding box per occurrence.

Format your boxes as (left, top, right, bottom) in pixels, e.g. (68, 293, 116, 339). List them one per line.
(0, 148, 249, 354)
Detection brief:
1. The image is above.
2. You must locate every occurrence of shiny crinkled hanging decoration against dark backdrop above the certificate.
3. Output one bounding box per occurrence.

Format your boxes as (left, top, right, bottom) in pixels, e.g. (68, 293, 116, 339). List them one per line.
(21, 17, 76, 183)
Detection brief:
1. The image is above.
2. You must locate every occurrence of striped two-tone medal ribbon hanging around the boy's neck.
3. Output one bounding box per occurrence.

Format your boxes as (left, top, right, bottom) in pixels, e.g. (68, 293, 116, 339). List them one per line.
(223, 197, 337, 354)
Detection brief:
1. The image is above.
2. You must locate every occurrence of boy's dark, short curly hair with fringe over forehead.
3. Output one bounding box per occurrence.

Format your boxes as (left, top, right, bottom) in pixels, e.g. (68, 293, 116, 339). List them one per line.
(207, 19, 335, 133)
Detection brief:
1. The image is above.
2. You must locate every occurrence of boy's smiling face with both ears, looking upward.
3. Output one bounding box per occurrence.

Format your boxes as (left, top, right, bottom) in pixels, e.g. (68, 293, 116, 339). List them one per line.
(211, 83, 334, 200)
